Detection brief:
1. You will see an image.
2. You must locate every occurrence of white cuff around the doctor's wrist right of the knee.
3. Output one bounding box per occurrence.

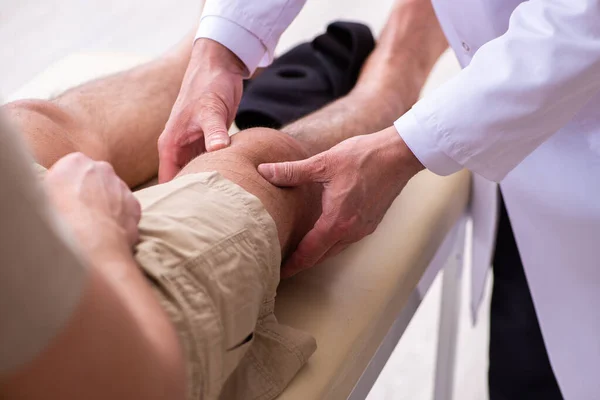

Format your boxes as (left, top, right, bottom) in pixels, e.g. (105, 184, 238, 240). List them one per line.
(394, 110, 463, 175)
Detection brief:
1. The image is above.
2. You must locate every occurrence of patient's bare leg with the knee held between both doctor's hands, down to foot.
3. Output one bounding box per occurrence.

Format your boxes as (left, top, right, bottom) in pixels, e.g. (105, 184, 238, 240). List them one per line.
(173, 1, 446, 256)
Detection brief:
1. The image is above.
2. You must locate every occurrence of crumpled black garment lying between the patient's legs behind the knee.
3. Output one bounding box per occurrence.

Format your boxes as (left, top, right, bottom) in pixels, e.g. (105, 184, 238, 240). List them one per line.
(235, 22, 375, 129)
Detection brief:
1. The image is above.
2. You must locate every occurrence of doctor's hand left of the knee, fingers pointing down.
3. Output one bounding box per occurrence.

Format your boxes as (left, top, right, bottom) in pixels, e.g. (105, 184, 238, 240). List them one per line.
(158, 39, 246, 183)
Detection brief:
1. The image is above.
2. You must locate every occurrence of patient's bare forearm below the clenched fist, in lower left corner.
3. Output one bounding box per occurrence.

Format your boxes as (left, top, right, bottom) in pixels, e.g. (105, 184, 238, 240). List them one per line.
(0, 254, 186, 400)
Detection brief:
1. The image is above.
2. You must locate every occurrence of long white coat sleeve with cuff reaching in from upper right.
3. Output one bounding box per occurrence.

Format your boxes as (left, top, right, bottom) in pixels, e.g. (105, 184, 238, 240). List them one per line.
(395, 0, 600, 181)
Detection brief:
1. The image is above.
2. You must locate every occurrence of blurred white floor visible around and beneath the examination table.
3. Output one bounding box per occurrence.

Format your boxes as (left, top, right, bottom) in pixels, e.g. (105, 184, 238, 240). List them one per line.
(0, 0, 489, 400)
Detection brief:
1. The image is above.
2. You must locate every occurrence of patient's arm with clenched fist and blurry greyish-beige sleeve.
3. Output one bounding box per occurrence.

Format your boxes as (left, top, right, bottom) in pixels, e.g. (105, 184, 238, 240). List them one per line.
(0, 152, 185, 400)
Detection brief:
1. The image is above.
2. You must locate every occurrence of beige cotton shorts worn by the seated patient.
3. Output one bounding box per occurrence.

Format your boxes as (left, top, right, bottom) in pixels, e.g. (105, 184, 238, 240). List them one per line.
(36, 166, 316, 400)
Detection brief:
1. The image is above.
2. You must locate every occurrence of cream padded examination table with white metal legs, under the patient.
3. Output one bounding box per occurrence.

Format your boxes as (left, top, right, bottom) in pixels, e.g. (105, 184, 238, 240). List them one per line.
(10, 53, 470, 400)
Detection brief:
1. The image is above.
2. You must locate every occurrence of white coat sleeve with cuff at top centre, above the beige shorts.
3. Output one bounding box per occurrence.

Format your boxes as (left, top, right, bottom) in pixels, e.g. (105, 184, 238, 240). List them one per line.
(196, 0, 306, 74)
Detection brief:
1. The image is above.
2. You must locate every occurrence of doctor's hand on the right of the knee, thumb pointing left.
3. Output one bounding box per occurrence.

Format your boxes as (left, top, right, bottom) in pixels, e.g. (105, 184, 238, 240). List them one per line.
(258, 127, 423, 277)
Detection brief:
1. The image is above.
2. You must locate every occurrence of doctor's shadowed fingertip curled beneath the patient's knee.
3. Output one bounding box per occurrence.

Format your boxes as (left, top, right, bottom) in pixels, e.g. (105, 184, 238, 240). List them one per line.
(281, 217, 339, 278)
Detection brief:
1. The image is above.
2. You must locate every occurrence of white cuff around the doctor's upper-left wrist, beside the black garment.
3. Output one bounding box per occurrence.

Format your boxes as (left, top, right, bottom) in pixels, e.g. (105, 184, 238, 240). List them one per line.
(195, 15, 267, 77)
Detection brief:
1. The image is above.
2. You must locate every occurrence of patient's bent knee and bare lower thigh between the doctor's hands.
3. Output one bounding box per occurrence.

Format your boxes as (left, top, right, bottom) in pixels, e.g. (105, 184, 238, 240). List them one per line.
(181, 128, 321, 255)
